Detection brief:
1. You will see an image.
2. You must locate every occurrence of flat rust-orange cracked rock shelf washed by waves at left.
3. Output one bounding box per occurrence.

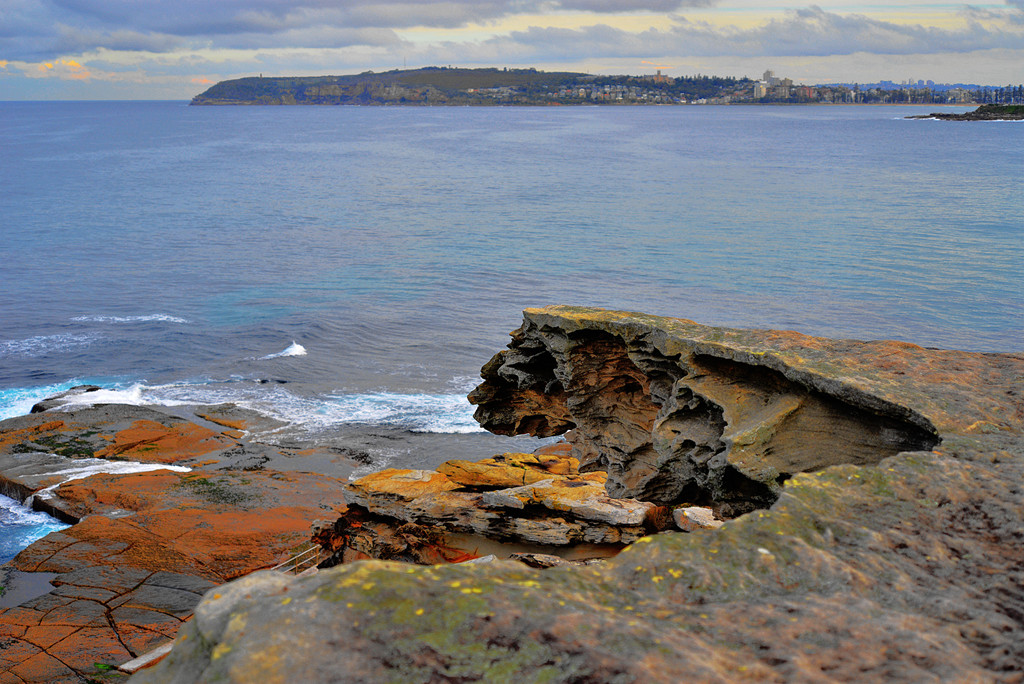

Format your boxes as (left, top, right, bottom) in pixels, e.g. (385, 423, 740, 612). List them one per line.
(0, 400, 352, 683)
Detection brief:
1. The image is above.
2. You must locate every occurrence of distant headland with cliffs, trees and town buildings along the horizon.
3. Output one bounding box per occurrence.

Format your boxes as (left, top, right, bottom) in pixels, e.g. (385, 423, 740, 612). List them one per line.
(191, 67, 1024, 106)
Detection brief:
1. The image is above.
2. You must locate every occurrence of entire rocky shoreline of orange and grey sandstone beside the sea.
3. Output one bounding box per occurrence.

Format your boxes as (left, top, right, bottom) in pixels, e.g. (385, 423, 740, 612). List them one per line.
(0, 307, 1024, 683)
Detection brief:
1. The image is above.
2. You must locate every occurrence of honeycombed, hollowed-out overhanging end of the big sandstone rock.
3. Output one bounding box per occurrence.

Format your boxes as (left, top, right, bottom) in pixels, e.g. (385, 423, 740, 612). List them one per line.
(470, 307, 938, 516)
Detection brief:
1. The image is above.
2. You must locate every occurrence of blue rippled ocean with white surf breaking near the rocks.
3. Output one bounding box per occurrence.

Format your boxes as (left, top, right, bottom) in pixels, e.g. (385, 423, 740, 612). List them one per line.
(0, 101, 1024, 560)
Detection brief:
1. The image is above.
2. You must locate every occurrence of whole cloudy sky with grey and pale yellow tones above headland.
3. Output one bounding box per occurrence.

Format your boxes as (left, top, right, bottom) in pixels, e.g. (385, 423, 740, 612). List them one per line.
(0, 0, 1024, 100)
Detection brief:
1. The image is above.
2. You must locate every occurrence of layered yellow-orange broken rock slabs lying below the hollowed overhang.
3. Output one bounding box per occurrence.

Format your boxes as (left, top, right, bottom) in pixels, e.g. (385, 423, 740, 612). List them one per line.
(317, 446, 696, 565)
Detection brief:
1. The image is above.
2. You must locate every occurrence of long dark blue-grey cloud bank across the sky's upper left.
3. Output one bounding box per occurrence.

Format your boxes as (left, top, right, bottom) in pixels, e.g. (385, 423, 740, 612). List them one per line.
(0, 0, 729, 59)
